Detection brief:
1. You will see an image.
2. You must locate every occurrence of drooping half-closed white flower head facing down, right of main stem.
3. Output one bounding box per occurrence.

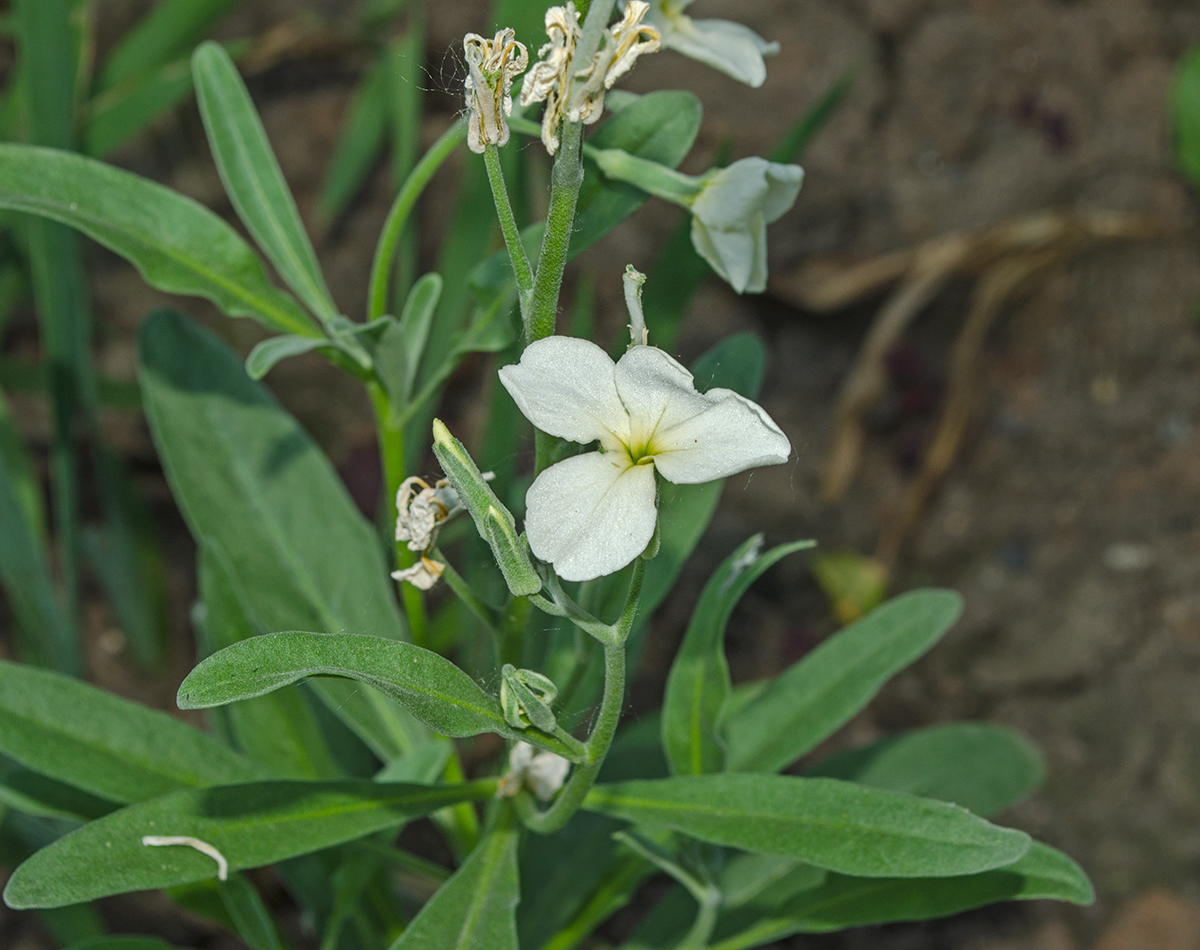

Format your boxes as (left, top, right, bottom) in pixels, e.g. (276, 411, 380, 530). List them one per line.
(691, 158, 804, 294)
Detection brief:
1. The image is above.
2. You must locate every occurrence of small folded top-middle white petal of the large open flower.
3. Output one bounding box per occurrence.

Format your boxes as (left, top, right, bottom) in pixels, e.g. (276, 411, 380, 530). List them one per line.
(616, 347, 709, 448)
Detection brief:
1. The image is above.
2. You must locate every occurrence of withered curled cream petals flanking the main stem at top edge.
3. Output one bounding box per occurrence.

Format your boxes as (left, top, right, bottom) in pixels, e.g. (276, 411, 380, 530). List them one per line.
(521, 0, 659, 155)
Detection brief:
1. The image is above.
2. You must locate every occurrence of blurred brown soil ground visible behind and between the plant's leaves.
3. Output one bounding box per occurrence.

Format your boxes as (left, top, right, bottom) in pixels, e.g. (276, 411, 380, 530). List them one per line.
(0, 0, 1200, 950)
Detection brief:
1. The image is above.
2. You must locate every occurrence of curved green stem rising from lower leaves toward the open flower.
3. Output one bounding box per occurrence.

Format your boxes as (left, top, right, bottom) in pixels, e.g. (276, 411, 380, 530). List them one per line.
(516, 558, 646, 835)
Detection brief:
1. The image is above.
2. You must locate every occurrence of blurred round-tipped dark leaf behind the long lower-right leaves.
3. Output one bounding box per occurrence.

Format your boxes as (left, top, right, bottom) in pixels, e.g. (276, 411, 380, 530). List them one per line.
(805, 722, 1045, 818)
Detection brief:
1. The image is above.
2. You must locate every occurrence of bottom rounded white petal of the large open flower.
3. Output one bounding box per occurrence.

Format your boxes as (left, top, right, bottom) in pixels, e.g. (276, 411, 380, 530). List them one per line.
(524, 452, 658, 581)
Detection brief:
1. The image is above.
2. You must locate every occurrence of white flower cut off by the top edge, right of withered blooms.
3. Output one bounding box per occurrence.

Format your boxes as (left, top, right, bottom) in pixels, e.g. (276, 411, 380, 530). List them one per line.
(628, 0, 779, 89)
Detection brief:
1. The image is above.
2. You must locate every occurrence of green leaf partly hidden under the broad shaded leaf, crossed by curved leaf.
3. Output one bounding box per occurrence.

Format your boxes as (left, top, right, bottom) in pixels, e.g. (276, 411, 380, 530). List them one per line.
(193, 549, 338, 781)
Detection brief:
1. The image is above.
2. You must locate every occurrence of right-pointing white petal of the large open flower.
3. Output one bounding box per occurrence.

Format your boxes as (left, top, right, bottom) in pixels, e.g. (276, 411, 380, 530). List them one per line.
(654, 389, 792, 485)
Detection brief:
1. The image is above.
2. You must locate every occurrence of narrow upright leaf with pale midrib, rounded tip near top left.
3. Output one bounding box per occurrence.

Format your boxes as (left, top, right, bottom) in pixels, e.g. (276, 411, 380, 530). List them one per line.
(192, 42, 337, 320)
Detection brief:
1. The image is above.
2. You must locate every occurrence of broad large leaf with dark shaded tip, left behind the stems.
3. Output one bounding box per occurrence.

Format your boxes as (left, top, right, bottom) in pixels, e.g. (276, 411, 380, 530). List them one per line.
(139, 311, 421, 759)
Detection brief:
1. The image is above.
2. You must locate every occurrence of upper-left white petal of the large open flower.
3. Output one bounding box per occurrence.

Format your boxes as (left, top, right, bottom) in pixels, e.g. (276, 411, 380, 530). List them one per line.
(500, 336, 629, 448)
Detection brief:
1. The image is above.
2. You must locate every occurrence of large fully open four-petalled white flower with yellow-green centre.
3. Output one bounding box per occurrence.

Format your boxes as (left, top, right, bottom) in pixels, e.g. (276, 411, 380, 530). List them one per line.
(500, 336, 792, 581)
